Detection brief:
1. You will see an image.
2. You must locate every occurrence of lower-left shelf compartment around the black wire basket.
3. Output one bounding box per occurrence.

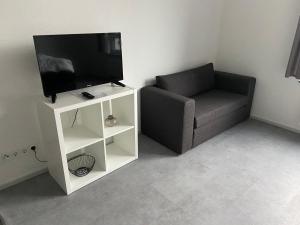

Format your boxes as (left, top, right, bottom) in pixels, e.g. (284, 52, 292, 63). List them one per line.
(67, 141, 107, 191)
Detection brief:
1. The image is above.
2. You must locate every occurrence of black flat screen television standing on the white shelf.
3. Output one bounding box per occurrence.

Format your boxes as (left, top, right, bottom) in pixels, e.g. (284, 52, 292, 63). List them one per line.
(33, 33, 123, 101)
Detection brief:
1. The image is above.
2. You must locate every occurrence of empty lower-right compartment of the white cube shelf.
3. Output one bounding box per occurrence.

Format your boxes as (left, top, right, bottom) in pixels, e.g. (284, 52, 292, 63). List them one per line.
(106, 129, 137, 171)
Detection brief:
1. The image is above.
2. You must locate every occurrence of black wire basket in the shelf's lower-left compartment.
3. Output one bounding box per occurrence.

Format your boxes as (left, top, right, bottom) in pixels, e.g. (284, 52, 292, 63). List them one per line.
(68, 153, 96, 177)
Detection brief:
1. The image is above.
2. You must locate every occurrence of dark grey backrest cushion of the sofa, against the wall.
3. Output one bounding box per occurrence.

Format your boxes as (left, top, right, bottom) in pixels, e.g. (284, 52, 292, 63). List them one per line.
(156, 63, 215, 97)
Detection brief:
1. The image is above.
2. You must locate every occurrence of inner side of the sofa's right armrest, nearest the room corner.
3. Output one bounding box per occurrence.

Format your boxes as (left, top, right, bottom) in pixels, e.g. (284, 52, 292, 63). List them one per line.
(215, 71, 256, 97)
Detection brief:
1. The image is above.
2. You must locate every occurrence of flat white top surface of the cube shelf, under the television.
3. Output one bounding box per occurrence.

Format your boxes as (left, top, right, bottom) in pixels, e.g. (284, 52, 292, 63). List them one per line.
(44, 84, 135, 111)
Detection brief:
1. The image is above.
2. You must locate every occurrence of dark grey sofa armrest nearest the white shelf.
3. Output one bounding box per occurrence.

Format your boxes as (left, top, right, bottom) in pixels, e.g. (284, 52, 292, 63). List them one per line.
(141, 86, 195, 154)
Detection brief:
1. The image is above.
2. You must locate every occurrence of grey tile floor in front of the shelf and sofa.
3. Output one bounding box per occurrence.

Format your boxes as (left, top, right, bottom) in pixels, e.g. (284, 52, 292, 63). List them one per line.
(0, 120, 300, 225)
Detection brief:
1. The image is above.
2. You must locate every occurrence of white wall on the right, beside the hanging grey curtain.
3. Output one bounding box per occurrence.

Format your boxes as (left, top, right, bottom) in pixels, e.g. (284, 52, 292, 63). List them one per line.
(217, 0, 300, 131)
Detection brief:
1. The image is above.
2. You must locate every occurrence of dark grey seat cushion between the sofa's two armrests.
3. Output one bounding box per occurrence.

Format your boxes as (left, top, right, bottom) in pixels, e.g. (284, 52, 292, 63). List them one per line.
(193, 89, 248, 128)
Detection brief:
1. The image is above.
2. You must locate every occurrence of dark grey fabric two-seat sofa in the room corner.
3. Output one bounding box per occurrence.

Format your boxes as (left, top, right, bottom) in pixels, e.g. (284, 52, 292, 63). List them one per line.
(141, 63, 256, 154)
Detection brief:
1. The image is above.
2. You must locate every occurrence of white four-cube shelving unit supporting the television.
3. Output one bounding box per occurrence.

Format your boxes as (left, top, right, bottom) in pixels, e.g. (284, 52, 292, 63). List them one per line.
(38, 84, 138, 194)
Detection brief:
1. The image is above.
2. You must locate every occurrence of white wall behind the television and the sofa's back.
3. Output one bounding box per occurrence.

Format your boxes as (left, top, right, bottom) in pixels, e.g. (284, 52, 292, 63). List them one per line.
(0, 0, 222, 186)
